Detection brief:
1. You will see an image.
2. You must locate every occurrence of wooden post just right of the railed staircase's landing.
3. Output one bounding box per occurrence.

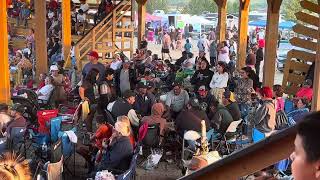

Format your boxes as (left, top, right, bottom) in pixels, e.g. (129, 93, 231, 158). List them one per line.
(137, 0, 147, 47)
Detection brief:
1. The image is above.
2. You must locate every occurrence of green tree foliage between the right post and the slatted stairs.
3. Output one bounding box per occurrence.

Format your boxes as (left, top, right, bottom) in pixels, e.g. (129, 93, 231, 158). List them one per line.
(281, 0, 317, 21)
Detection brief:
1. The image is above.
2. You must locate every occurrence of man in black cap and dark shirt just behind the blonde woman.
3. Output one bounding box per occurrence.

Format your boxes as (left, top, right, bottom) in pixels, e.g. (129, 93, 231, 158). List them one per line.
(111, 90, 135, 118)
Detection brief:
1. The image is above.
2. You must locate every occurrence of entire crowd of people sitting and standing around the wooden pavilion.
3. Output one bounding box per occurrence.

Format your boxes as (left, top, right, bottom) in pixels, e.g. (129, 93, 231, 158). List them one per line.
(0, 0, 319, 177)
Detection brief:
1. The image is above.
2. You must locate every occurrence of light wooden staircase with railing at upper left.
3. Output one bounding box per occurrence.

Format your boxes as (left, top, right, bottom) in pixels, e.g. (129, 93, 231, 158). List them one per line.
(75, 0, 134, 69)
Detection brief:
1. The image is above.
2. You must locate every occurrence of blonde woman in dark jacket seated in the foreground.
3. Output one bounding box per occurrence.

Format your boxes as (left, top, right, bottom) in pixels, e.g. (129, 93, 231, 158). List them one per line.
(98, 122, 133, 171)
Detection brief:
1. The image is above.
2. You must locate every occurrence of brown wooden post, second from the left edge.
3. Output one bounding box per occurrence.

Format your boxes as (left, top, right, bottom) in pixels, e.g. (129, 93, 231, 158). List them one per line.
(34, 0, 48, 77)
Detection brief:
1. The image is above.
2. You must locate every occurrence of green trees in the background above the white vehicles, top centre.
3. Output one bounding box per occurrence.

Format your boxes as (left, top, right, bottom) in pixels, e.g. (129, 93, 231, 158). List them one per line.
(183, 0, 218, 15)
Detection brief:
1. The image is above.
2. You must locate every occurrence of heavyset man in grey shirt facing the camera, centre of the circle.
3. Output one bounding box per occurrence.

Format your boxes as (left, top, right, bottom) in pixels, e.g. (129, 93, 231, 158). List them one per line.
(165, 82, 189, 118)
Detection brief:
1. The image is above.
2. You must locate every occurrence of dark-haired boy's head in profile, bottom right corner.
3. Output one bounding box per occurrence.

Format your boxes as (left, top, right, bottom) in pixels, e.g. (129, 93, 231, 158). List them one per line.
(290, 112, 320, 180)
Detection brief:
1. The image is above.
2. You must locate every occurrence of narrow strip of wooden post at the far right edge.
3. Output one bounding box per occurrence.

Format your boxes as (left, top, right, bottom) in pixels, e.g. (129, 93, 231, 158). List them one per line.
(312, 0, 320, 111)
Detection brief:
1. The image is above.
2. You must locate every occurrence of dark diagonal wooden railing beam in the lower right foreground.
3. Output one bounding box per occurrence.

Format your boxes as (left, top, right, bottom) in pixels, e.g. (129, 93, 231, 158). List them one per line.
(180, 126, 296, 180)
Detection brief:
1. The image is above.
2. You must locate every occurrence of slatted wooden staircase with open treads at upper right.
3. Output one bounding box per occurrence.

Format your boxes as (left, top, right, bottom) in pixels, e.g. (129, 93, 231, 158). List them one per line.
(282, 0, 320, 95)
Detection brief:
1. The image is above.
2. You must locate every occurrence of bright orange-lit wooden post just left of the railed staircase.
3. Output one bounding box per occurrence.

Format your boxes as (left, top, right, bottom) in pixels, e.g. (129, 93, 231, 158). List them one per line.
(61, 0, 71, 67)
